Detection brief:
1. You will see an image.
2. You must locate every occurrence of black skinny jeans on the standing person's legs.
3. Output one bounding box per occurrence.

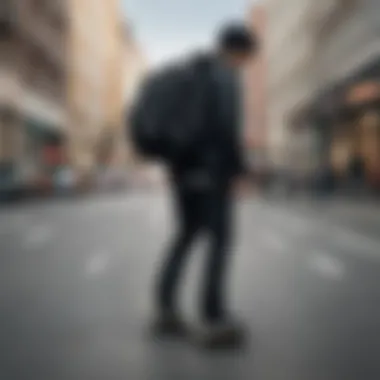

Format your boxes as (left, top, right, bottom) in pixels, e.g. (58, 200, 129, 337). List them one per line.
(158, 177, 231, 322)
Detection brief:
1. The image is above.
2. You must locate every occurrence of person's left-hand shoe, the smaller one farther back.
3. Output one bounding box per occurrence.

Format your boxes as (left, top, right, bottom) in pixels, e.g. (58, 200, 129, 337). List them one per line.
(152, 313, 188, 338)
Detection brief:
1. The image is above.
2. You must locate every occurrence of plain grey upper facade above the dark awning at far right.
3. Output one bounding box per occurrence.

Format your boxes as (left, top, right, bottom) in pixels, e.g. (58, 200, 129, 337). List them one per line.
(315, 0, 380, 89)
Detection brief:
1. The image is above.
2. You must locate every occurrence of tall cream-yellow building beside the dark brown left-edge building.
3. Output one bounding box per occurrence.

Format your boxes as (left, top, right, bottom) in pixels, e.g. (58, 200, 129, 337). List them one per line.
(67, 0, 124, 177)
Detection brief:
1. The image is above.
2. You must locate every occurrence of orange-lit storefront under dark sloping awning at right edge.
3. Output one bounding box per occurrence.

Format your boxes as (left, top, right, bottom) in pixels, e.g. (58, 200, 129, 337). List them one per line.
(311, 58, 380, 191)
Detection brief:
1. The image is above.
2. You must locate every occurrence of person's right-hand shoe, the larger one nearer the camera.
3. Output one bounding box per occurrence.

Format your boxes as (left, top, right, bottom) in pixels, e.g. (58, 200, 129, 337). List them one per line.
(199, 321, 247, 350)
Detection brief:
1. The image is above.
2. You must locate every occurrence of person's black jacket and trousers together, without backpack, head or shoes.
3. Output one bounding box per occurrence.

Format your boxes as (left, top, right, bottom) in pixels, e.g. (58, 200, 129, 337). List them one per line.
(158, 52, 244, 322)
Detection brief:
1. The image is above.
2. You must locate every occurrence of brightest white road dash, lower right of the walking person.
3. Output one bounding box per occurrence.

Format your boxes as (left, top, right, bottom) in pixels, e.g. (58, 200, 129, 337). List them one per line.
(309, 252, 347, 281)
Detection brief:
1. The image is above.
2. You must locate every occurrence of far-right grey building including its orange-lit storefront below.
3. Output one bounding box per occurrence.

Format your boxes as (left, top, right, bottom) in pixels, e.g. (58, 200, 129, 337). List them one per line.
(312, 0, 380, 190)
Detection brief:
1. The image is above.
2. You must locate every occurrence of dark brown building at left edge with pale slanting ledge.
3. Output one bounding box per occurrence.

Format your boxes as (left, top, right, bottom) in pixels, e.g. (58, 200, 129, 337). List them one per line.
(0, 0, 68, 194)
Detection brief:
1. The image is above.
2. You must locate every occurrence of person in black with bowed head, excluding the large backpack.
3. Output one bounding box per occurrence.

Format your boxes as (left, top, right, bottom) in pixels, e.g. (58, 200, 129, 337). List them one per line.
(154, 23, 257, 346)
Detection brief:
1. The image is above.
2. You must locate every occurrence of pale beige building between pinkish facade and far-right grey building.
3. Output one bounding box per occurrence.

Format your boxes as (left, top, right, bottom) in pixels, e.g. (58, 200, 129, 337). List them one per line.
(266, 0, 316, 169)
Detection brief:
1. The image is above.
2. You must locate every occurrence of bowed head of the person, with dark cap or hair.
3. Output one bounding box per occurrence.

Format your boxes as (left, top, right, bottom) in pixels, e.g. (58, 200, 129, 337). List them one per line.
(217, 23, 259, 68)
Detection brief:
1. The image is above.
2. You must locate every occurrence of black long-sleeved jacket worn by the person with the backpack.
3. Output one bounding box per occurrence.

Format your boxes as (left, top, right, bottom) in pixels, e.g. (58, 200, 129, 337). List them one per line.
(173, 55, 245, 187)
